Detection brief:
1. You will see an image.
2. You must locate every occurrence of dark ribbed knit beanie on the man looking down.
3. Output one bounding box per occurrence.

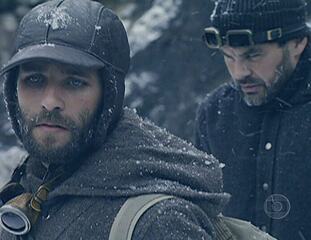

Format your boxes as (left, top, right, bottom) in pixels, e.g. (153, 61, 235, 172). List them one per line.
(211, 0, 308, 43)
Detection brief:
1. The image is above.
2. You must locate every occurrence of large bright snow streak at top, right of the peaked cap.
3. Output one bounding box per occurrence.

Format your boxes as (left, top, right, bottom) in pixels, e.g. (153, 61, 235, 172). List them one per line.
(128, 0, 182, 56)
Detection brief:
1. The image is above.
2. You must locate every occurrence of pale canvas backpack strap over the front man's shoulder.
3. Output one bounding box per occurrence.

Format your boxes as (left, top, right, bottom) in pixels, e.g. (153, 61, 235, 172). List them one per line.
(109, 194, 175, 240)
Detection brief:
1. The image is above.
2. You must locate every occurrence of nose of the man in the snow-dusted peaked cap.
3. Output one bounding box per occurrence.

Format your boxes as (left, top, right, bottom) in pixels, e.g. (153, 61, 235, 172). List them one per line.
(41, 87, 65, 111)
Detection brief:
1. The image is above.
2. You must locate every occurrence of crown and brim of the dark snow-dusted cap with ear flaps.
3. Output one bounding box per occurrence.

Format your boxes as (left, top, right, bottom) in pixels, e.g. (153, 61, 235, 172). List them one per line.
(0, 0, 130, 75)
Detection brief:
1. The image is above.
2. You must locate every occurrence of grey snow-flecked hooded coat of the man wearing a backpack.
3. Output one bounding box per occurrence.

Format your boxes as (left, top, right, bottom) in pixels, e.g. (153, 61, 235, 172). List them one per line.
(0, 109, 228, 240)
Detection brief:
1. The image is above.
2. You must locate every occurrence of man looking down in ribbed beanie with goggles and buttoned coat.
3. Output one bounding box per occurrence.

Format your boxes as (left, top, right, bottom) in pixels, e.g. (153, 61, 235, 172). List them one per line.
(196, 0, 311, 240)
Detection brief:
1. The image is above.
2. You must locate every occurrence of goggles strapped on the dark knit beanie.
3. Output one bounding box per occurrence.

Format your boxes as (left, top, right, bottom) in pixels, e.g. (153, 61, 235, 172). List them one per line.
(203, 27, 283, 49)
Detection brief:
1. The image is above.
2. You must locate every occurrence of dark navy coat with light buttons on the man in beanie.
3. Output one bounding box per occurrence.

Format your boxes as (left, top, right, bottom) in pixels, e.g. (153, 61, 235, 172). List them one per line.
(196, 43, 311, 240)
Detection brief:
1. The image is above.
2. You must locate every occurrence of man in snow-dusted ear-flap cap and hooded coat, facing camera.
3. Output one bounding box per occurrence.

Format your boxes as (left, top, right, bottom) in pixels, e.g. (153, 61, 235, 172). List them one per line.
(0, 0, 232, 240)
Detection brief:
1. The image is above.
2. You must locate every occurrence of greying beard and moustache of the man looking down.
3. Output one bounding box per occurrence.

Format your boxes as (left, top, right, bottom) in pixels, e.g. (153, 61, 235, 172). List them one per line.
(233, 46, 294, 106)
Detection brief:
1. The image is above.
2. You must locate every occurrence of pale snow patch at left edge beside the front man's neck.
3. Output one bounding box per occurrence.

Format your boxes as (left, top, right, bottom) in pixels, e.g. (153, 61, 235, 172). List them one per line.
(0, 147, 25, 188)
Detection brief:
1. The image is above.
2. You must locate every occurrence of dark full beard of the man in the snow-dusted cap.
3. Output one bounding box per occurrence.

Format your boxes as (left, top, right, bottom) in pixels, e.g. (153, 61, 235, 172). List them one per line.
(17, 110, 95, 167)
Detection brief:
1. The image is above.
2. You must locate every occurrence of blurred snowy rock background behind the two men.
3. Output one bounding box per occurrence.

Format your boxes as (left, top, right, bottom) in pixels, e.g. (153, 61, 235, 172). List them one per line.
(0, 0, 311, 186)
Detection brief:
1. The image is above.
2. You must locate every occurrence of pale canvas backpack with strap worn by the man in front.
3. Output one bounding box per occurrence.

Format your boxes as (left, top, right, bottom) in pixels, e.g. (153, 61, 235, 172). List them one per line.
(109, 194, 277, 240)
